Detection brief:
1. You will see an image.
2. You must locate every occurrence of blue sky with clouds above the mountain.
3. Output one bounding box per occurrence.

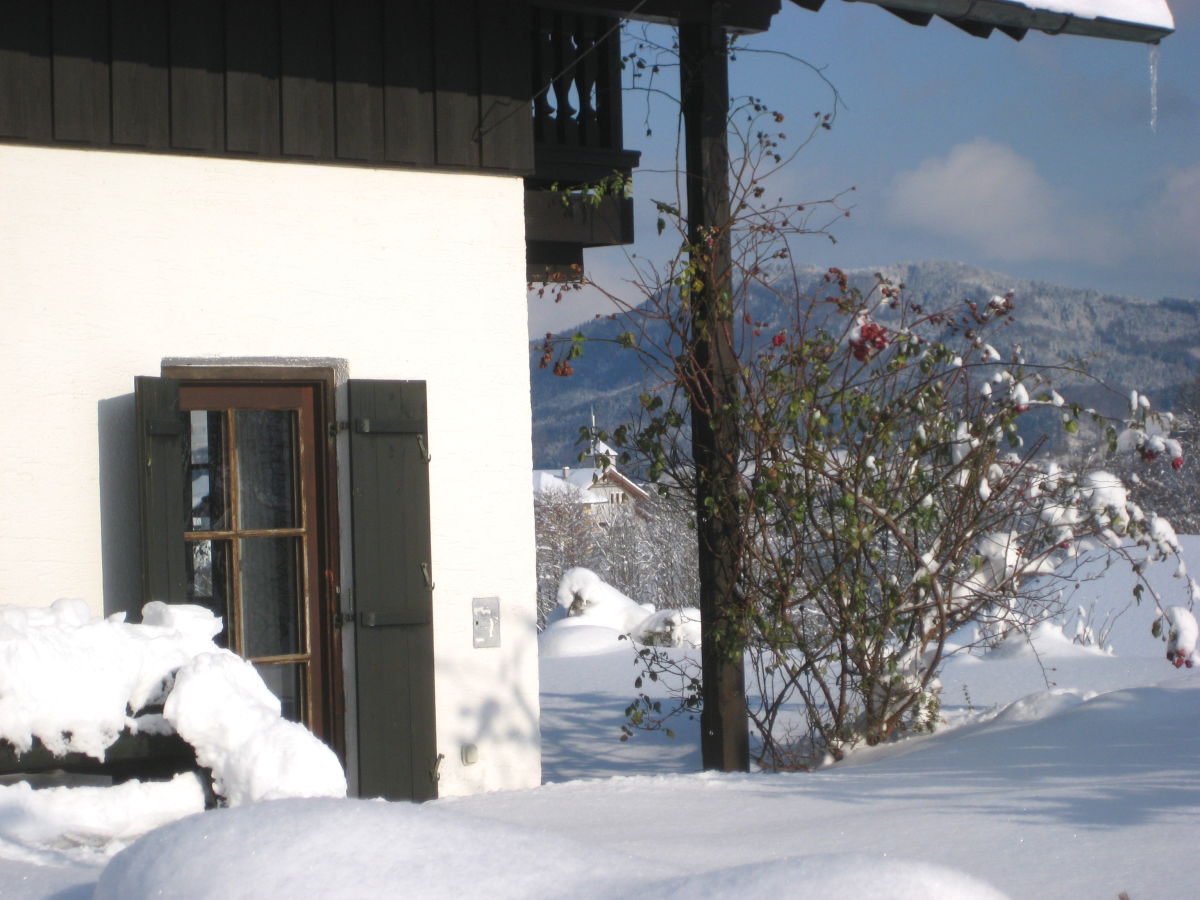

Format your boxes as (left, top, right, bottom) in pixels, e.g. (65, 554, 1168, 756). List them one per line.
(530, 0, 1200, 334)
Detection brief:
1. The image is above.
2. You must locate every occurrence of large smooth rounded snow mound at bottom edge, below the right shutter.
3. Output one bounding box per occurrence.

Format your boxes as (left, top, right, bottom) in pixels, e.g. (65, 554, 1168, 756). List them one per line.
(95, 799, 632, 900)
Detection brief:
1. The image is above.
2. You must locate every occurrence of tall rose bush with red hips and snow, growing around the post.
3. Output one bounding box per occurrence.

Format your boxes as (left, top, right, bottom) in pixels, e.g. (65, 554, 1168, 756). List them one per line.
(544, 90, 1195, 767)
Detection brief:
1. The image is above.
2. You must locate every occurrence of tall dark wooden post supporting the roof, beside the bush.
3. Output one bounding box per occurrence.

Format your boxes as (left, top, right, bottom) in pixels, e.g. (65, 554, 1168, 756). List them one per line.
(679, 4, 750, 772)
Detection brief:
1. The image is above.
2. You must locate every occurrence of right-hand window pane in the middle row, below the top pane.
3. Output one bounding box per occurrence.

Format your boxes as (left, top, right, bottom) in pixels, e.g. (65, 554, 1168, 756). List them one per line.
(240, 538, 304, 659)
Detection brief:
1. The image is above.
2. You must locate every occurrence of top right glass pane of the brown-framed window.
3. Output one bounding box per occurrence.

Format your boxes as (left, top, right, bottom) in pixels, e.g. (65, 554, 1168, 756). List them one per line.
(234, 409, 300, 529)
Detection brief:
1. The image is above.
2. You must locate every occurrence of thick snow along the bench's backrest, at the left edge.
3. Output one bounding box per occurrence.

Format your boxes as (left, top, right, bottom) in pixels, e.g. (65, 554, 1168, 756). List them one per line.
(0, 600, 221, 760)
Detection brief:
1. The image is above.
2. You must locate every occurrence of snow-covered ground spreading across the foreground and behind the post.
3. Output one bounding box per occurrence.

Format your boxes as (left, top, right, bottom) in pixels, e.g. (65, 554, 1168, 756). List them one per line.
(0, 538, 1200, 900)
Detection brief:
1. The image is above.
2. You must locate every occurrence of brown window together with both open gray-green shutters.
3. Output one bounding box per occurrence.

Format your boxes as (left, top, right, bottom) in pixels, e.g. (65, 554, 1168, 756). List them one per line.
(136, 374, 437, 800)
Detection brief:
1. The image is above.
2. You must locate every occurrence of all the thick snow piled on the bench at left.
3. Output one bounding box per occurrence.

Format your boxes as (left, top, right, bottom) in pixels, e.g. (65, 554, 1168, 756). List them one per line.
(0, 600, 346, 859)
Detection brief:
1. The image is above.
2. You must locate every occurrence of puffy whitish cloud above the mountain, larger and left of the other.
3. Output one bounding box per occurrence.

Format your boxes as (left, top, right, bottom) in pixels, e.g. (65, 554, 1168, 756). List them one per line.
(886, 138, 1122, 263)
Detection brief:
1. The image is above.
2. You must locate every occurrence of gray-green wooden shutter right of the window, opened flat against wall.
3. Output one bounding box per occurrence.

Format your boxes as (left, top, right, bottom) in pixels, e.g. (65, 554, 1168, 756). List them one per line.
(349, 379, 437, 800)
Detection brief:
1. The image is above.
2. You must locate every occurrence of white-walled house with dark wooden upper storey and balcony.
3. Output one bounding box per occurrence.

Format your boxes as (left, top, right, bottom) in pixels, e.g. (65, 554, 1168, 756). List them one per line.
(0, 0, 1166, 799)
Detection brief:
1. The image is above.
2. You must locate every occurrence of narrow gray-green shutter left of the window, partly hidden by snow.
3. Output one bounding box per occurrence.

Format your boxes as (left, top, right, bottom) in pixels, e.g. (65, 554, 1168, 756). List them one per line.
(134, 377, 187, 604)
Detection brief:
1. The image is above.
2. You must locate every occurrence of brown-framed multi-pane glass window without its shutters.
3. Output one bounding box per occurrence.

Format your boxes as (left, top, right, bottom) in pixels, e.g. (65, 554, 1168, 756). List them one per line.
(179, 384, 324, 731)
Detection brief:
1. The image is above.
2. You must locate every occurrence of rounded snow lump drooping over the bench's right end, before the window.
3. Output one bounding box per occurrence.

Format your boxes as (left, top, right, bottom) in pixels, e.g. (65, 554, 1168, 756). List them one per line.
(163, 650, 346, 806)
